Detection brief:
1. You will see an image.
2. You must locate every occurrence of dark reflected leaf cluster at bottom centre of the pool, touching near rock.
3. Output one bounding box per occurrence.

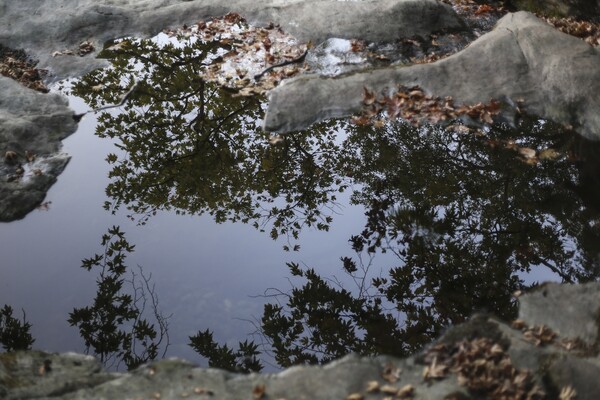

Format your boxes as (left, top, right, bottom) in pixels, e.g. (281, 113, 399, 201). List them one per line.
(260, 259, 410, 367)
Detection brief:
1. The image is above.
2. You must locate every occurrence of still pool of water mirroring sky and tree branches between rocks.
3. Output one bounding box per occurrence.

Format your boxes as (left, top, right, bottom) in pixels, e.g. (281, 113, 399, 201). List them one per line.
(0, 25, 600, 368)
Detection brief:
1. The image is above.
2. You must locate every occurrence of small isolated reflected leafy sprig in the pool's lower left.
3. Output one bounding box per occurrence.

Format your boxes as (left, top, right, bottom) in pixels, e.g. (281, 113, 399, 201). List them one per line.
(68, 227, 169, 369)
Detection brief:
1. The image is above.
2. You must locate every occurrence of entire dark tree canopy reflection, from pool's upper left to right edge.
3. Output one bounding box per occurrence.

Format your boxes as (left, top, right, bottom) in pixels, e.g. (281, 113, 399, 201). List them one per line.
(65, 34, 600, 371)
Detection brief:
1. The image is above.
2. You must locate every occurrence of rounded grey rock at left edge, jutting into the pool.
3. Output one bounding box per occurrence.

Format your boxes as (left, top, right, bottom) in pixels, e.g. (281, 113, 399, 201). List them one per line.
(0, 76, 77, 222)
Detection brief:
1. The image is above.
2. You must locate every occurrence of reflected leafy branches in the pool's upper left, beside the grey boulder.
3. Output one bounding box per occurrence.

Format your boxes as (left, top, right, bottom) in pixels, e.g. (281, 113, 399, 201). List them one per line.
(73, 36, 344, 238)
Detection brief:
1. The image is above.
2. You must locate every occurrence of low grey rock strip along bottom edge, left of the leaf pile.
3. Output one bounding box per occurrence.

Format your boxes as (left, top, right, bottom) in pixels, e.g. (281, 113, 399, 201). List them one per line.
(0, 352, 470, 400)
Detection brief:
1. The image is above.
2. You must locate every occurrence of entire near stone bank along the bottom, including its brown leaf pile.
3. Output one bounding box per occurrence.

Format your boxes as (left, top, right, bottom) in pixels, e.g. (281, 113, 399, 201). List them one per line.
(0, 283, 600, 400)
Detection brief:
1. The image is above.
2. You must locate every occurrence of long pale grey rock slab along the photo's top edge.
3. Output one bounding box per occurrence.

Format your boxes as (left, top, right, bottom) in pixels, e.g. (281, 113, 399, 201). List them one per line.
(0, 0, 464, 79)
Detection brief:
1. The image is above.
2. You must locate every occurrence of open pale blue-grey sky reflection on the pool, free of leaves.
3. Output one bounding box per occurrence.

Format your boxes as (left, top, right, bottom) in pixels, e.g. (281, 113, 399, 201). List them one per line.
(0, 94, 363, 362)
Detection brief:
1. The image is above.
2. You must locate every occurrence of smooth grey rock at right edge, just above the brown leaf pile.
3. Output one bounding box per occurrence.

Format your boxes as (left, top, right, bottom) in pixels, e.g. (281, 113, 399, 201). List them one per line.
(519, 282, 600, 345)
